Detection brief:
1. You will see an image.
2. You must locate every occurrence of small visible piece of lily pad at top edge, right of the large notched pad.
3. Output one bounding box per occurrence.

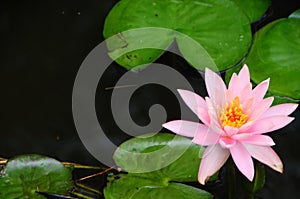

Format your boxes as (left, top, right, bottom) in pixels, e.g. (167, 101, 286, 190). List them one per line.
(232, 0, 271, 22)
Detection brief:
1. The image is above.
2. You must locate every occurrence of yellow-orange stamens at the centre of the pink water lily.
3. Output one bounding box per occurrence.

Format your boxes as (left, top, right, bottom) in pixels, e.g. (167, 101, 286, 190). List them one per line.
(220, 97, 249, 128)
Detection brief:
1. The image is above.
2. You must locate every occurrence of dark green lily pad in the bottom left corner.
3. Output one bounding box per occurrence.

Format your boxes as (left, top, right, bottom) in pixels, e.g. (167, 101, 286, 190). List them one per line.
(0, 155, 73, 199)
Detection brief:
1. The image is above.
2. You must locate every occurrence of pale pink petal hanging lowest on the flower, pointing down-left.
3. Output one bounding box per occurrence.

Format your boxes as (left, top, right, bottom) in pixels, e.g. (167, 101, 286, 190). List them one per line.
(198, 145, 230, 185)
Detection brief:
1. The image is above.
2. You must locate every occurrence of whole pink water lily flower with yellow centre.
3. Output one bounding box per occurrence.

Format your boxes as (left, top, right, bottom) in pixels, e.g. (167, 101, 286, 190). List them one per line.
(163, 65, 297, 184)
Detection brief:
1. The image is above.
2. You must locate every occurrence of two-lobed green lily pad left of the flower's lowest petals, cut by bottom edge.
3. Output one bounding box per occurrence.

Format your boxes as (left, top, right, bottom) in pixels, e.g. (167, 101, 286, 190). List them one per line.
(104, 133, 216, 199)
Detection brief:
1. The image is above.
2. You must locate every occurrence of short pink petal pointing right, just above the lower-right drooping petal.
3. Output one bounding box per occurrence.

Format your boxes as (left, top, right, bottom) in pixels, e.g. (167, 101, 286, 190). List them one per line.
(233, 134, 275, 146)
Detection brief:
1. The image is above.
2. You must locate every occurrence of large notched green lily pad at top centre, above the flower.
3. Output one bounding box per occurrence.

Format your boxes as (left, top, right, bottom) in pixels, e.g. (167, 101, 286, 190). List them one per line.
(103, 0, 252, 70)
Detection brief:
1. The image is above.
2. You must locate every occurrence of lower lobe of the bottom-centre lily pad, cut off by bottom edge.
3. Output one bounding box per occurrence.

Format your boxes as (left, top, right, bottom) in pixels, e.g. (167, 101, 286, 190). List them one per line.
(104, 174, 212, 199)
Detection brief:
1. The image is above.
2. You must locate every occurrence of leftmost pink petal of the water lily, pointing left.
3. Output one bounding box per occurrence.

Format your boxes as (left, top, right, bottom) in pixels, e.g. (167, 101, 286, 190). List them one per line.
(162, 120, 208, 137)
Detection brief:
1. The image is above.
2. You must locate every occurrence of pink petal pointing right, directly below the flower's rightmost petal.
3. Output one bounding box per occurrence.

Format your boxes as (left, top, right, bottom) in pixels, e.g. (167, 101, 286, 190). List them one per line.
(245, 116, 294, 134)
